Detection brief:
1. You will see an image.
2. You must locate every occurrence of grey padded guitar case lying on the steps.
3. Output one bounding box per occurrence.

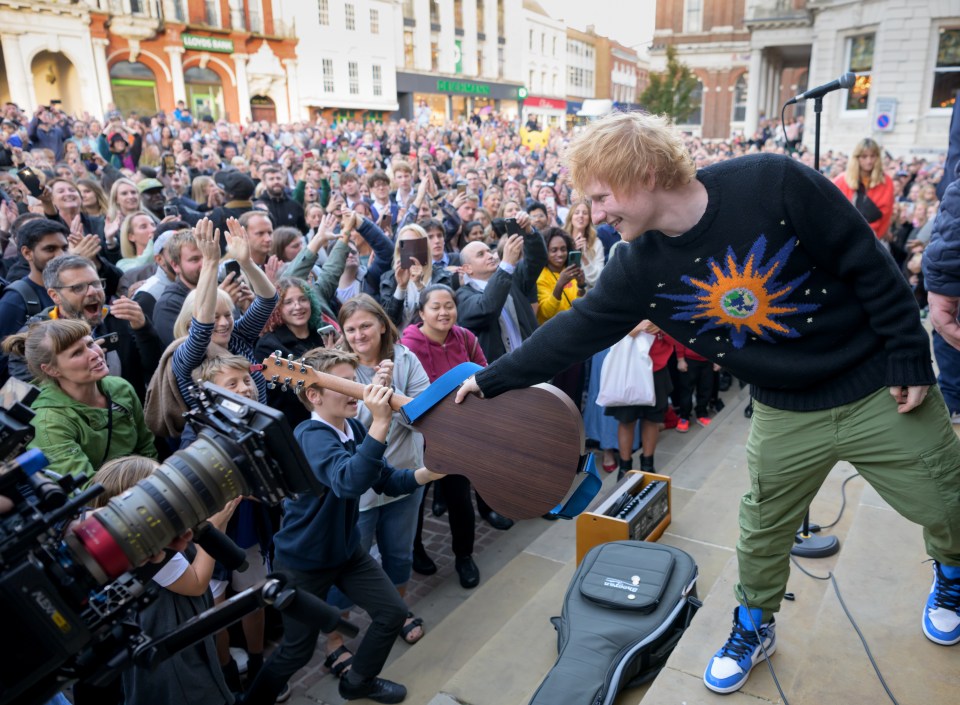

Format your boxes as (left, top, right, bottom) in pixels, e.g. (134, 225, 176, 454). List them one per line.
(530, 541, 701, 705)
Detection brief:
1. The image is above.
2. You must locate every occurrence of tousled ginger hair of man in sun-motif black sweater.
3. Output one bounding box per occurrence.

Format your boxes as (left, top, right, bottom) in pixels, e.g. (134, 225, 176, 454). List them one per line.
(564, 112, 697, 195)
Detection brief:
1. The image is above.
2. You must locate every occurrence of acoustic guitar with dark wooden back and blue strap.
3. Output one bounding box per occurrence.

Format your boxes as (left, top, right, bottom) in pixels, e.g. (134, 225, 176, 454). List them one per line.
(263, 354, 584, 519)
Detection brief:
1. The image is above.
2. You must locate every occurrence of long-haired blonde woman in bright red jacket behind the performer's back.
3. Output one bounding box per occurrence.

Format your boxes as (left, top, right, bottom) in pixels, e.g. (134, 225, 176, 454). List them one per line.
(833, 137, 893, 240)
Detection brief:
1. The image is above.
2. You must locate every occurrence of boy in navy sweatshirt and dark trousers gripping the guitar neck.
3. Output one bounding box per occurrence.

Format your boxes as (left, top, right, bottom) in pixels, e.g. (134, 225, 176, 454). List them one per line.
(244, 348, 443, 705)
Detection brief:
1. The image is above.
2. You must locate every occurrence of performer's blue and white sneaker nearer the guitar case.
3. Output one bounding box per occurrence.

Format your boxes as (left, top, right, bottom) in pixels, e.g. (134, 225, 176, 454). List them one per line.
(703, 606, 777, 693)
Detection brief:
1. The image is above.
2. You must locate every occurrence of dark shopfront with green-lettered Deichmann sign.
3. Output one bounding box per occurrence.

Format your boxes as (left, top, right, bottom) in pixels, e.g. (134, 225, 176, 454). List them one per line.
(397, 72, 520, 125)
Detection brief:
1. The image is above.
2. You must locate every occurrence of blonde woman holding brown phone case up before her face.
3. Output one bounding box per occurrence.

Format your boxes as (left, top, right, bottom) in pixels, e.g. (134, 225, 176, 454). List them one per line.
(380, 225, 453, 330)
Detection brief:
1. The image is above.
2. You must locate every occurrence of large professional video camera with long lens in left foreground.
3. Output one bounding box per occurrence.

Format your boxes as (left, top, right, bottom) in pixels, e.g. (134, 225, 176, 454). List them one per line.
(0, 383, 356, 705)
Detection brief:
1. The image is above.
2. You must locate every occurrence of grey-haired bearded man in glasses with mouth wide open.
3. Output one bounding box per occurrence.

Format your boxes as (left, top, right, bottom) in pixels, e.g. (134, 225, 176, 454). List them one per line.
(10, 255, 163, 401)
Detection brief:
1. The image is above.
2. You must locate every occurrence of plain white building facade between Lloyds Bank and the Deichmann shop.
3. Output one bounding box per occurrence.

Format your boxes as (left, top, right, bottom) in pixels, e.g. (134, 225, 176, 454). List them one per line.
(289, 0, 401, 121)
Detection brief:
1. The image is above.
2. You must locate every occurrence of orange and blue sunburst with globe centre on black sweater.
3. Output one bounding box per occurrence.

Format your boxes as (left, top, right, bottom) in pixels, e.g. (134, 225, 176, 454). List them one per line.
(657, 235, 820, 349)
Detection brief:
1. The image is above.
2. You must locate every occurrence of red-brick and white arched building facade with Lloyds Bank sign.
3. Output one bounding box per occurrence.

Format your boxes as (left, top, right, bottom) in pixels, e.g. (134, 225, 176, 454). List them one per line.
(0, 0, 299, 122)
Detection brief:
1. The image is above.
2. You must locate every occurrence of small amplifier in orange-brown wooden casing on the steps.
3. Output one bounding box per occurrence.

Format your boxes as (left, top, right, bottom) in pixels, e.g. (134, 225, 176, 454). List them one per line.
(577, 470, 670, 564)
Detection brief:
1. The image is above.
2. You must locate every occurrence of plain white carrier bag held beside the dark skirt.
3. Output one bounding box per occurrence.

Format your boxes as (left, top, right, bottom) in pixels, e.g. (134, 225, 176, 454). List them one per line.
(597, 333, 657, 406)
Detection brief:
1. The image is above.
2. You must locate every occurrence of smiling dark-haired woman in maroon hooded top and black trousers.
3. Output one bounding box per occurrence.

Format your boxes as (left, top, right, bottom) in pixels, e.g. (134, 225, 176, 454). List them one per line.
(400, 284, 487, 588)
